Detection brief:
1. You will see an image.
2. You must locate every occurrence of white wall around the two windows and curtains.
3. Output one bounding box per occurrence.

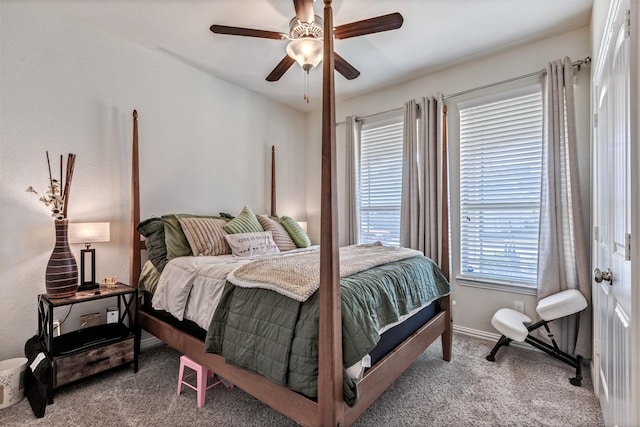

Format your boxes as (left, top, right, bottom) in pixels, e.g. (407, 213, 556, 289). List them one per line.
(307, 27, 591, 333)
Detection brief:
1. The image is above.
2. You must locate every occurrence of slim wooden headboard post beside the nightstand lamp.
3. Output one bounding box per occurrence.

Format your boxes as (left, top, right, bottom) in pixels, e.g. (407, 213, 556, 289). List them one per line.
(129, 110, 142, 288)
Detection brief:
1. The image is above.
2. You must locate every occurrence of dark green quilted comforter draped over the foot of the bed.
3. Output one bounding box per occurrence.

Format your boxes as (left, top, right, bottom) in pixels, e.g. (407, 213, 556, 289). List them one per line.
(205, 257, 450, 406)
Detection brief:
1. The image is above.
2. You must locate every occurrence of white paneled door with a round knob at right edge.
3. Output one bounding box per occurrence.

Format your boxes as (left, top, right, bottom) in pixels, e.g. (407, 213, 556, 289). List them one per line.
(592, 0, 638, 426)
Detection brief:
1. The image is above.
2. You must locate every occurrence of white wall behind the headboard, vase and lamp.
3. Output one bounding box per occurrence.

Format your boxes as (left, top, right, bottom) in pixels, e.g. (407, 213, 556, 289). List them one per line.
(0, 0, 306, 360)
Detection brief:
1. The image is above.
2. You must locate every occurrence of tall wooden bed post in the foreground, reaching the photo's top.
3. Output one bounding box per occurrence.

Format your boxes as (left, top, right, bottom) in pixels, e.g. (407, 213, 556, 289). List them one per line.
(318, 0, 344, 426)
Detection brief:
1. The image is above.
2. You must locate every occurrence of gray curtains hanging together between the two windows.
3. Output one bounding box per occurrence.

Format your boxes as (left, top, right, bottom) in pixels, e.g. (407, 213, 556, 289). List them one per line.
(400, 97, 442, 264)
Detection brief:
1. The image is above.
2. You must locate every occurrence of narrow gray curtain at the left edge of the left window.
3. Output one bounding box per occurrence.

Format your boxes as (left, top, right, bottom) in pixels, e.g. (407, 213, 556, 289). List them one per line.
(345, 116, 362, 245)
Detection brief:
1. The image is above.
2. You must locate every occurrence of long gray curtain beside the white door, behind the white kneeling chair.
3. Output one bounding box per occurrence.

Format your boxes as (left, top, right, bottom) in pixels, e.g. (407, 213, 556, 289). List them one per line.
(538, 57, 591, 357)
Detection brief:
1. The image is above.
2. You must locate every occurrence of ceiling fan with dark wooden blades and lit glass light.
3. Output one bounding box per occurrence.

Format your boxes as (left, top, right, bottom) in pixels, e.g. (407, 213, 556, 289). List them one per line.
(210, 0, 404, 82)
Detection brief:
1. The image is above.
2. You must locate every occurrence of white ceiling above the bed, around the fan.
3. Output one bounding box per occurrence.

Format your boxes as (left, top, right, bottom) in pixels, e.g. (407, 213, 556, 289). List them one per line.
(42, 0, 593, 111)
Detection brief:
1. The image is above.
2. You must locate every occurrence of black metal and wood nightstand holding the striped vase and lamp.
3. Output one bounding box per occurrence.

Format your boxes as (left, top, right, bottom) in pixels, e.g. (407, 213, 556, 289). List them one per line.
(38, 283, 140, 403)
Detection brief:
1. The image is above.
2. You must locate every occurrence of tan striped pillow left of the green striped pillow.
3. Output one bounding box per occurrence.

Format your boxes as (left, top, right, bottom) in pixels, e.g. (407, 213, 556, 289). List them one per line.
(180, 218, 231, 256)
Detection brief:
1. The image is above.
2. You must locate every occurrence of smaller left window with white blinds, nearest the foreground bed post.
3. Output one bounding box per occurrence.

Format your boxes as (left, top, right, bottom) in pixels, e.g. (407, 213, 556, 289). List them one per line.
(359, 116, 403, 246)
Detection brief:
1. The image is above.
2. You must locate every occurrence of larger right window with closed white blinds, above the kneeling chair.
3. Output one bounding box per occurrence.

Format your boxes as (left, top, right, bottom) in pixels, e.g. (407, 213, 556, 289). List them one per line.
(460, 86, 543, 287)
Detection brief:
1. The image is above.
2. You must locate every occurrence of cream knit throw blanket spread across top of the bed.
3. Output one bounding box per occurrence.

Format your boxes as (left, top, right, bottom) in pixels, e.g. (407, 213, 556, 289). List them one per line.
(227, 243, 422, 302)
